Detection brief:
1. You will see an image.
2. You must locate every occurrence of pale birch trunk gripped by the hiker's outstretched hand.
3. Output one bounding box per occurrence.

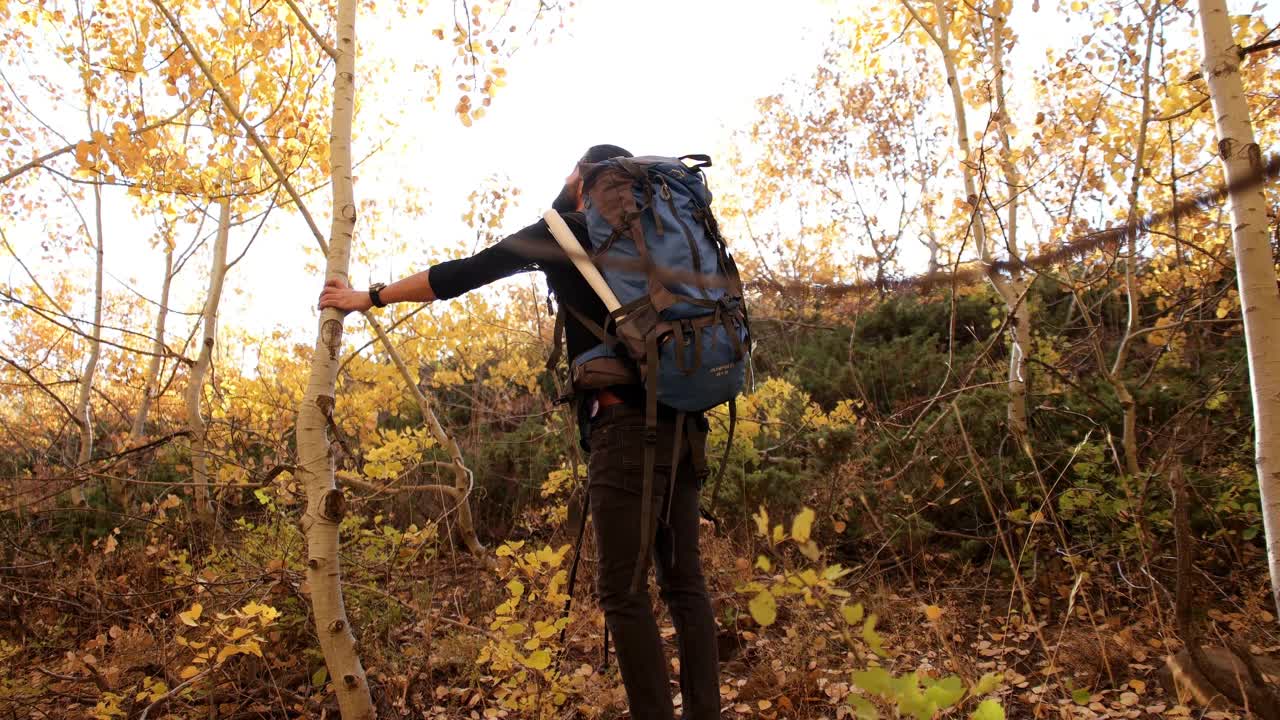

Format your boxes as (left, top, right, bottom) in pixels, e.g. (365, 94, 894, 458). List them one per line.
(297, 0, 374, 720)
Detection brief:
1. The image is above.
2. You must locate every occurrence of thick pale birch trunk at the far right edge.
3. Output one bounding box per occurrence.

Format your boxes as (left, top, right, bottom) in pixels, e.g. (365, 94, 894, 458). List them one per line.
(1199, 0, 1280, 620)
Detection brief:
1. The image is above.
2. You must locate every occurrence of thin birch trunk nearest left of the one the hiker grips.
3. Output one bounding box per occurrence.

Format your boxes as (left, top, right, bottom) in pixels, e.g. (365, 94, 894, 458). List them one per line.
(187, 197, 232, 520)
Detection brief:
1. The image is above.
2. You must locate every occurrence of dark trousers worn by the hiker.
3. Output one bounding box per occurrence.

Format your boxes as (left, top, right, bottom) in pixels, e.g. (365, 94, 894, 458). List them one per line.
(589, 405, 719, 720)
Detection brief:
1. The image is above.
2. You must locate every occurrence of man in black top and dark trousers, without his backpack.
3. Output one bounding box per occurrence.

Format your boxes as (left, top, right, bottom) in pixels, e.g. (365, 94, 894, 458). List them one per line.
(320, 145, 719, 720)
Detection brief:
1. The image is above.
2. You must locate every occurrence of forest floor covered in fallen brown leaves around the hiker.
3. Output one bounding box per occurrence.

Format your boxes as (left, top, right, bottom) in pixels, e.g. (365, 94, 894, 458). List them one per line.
(0, 507, 1280, 720)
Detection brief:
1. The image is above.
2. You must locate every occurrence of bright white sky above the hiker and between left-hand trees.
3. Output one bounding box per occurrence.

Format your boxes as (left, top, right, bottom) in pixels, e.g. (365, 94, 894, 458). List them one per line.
(0, 0, 1274, 353)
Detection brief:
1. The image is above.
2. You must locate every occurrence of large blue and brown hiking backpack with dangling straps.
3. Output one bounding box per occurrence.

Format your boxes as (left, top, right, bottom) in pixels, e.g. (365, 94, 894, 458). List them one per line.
(558, 155, 751, 587)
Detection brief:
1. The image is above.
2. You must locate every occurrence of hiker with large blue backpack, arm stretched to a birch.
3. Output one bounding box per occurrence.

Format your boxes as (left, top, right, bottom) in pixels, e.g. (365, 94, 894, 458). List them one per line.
(320, 145, 750, 720)
